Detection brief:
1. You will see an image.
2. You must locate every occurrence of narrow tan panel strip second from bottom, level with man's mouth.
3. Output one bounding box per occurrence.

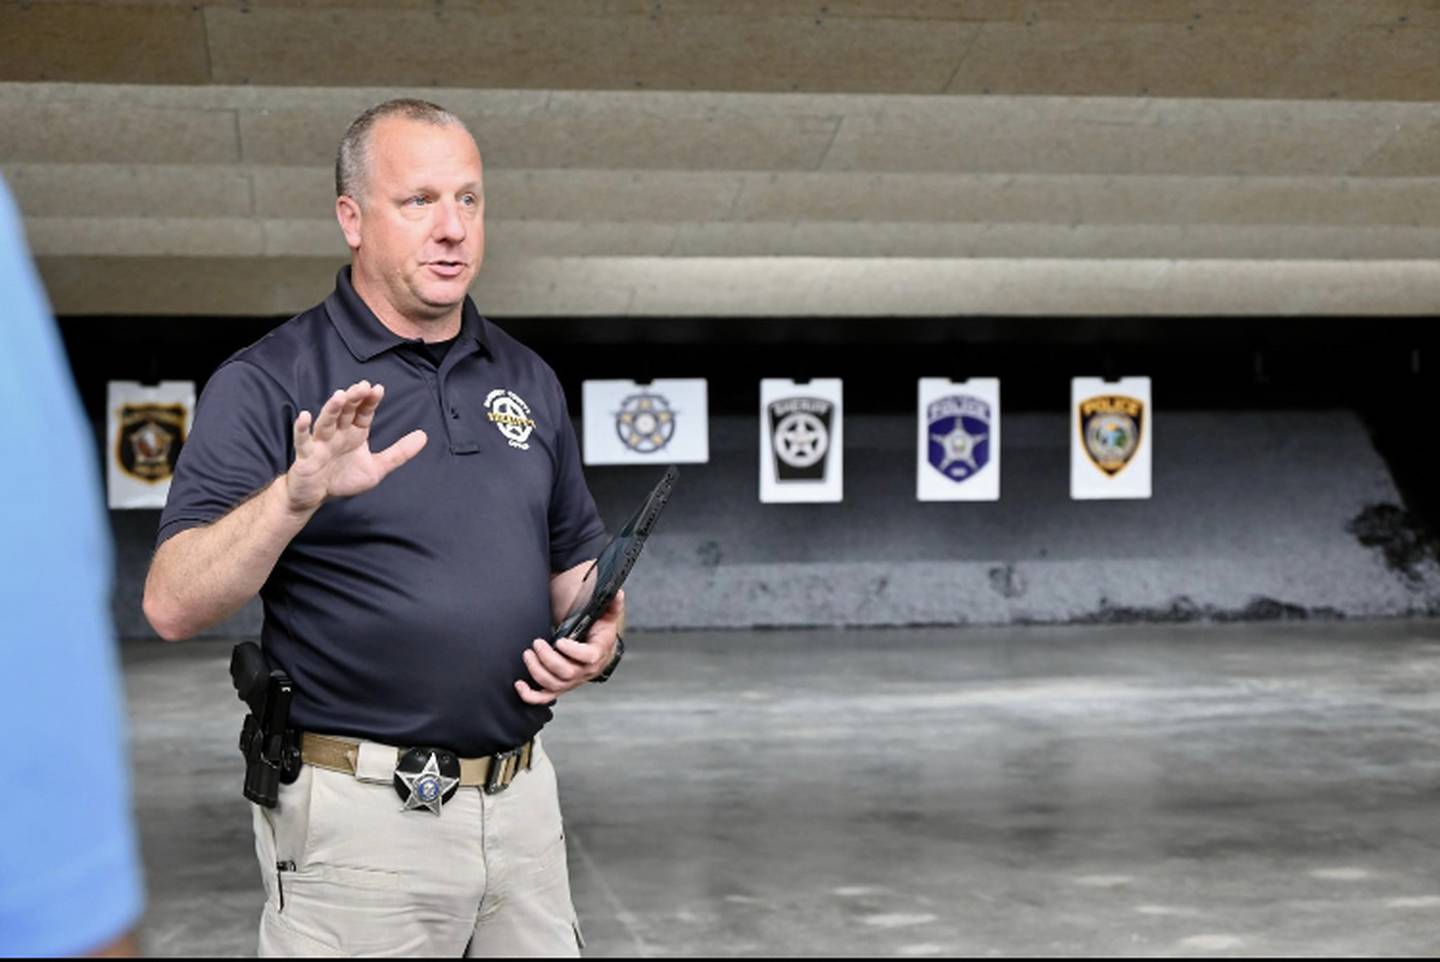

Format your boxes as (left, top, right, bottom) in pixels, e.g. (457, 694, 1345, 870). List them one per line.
(26, 217, 1440, 260)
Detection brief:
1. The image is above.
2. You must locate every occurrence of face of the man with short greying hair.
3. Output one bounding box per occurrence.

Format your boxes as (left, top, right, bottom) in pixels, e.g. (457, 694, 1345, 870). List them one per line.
(338, 117, 485, 321)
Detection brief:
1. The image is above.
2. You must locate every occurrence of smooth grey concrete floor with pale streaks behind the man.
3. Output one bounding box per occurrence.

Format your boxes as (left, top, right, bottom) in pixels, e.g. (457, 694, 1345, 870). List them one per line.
(124, 622, 1440, 956)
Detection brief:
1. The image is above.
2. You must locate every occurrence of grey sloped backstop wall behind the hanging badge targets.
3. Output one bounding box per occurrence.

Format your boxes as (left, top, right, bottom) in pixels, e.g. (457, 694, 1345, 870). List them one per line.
(112, 410, 1440, 637)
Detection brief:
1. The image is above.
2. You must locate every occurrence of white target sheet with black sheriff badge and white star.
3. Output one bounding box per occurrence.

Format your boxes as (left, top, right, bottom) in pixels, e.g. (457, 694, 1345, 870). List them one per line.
(760, 377, 844, 503)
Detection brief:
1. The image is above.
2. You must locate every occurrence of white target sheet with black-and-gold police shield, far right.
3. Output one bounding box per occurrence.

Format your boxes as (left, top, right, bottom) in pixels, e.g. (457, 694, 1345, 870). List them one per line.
(1070, 377, 1155, 500)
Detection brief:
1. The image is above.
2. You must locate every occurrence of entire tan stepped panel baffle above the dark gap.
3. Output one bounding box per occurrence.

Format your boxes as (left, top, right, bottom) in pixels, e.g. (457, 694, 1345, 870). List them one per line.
(0, 0, 1440, 317)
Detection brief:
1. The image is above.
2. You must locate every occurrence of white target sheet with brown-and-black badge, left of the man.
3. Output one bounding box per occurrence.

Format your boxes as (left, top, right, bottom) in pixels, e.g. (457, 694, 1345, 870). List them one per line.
(105, 380, 194, 508)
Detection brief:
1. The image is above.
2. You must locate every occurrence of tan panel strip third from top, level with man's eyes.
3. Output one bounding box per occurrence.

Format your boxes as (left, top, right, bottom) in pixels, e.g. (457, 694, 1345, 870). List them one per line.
(0, 163, 1440, 229)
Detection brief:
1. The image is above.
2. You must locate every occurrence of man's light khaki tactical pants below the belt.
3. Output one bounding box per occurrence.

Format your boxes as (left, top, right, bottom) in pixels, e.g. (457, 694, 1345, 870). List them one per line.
(252, 740, 582, 958)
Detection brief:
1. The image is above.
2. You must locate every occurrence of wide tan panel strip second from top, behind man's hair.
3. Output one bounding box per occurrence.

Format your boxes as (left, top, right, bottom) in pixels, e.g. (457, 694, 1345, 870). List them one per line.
(0, 84, 1440, 177)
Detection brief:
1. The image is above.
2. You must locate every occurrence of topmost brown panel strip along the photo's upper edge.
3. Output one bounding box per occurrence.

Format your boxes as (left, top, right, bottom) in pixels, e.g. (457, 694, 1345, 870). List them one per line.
(0, 0, 1440, 99)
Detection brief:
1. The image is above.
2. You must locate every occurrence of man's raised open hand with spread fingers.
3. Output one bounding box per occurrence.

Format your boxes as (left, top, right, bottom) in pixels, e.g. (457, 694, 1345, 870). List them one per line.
(285, 380, 426, 511)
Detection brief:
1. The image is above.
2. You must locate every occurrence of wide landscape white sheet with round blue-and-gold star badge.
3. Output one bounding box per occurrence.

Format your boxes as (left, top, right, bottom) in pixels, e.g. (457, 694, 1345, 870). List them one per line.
(582, 377, 710, 464)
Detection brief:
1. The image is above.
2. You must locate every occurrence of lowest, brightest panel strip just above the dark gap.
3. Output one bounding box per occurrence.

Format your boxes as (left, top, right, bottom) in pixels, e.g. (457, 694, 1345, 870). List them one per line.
(39, 256, 1440, 318)
